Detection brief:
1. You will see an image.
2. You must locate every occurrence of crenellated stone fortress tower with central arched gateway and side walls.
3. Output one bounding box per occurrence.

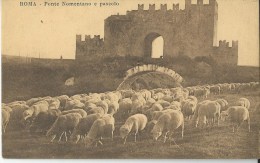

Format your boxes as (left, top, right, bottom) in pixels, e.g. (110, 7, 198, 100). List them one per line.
(76, 0, 238, 64)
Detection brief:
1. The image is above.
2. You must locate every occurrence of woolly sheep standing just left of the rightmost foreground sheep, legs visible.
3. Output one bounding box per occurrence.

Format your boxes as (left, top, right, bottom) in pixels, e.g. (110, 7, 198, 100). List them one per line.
(193, 100, 221, 127)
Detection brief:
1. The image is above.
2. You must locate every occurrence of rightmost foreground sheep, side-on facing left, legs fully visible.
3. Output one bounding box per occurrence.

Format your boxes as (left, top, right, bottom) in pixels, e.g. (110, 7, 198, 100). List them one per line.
(222, 106, 250, 132)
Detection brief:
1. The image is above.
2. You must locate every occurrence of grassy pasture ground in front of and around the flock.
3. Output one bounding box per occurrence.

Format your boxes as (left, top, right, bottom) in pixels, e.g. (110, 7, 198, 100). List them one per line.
(2, 89, 260, 159)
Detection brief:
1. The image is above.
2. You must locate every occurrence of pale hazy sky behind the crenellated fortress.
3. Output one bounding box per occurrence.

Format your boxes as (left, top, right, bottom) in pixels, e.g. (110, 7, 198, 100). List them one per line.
(2, 0, 259, 66)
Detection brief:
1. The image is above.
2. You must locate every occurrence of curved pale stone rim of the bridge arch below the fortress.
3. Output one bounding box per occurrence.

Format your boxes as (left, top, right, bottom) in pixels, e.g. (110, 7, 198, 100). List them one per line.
(117, 64, 184, 90)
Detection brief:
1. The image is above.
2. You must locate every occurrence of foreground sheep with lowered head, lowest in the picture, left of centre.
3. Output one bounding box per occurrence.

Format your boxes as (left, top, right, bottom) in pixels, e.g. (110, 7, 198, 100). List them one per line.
(85, 114, 115, 146)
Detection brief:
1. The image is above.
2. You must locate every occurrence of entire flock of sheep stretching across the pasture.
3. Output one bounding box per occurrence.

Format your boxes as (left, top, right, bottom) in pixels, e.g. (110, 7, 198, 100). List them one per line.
(2, 82, 259, 146)
